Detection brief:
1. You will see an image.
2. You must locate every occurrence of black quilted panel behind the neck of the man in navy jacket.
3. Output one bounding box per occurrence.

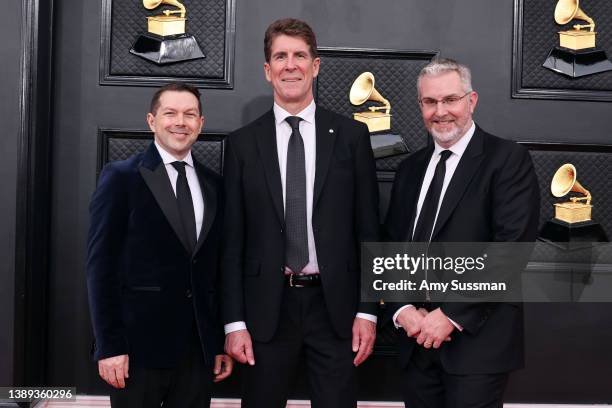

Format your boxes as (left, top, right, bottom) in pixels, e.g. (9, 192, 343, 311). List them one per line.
(98, 130, 224, 174)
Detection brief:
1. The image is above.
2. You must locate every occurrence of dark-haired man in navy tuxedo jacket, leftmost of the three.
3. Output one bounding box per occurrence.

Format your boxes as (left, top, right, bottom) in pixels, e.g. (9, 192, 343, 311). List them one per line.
(87, 83, 232, 408)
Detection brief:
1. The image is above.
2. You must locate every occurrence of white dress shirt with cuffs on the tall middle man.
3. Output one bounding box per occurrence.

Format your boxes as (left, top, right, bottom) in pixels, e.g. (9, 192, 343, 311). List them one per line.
(224, 100, 377, 334)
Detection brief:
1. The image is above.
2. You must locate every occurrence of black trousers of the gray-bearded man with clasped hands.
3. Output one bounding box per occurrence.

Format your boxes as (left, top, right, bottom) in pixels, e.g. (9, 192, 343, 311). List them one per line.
(402, 345, 508, 408)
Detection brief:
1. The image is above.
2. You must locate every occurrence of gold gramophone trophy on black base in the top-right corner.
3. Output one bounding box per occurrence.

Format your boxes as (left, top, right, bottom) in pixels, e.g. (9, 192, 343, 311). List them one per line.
(543, 0, 612, 78)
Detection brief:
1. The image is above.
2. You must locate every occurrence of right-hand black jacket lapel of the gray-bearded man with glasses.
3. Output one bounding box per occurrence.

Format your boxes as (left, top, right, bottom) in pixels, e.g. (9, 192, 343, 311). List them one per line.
(431, 127, 484, 241)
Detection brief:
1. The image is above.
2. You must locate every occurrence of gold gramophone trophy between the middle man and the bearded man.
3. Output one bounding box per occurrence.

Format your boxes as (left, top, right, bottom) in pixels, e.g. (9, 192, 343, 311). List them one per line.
(349, 72, 408, 159)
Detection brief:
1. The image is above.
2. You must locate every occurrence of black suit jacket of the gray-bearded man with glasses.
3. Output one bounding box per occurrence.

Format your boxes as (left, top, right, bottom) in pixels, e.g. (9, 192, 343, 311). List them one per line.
(385, 127, 540, 374)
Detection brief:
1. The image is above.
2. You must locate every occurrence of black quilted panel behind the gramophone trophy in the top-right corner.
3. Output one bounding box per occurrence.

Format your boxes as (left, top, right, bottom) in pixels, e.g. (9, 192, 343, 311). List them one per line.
(518, 0, 612, 91)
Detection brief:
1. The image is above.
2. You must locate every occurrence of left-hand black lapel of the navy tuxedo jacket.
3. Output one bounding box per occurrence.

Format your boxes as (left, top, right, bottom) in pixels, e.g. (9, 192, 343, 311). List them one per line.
(138, 143, 189, 251)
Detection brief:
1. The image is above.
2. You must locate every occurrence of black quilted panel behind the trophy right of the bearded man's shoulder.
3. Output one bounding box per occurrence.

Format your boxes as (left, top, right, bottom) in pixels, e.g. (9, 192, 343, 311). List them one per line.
(531, 150, 612, 237)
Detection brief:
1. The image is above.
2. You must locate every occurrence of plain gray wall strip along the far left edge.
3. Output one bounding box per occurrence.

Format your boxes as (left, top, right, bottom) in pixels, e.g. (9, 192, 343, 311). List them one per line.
(0, 0, 21, 385)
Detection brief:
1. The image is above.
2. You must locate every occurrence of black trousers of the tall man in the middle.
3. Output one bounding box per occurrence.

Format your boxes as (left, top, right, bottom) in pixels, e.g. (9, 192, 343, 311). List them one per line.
(242, 287, 357, 408)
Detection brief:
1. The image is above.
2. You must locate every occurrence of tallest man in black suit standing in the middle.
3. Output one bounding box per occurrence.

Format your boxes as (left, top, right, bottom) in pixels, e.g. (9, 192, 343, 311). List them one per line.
(222, 19, 378, 408)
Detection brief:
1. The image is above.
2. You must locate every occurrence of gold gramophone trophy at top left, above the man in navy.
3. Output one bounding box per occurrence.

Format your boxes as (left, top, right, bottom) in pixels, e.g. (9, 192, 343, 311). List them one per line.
(130, 0, 205, 65)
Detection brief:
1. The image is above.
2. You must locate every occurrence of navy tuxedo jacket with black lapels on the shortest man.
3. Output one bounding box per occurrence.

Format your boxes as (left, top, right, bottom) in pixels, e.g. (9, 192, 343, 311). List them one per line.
(87, 143, 223, 368)
